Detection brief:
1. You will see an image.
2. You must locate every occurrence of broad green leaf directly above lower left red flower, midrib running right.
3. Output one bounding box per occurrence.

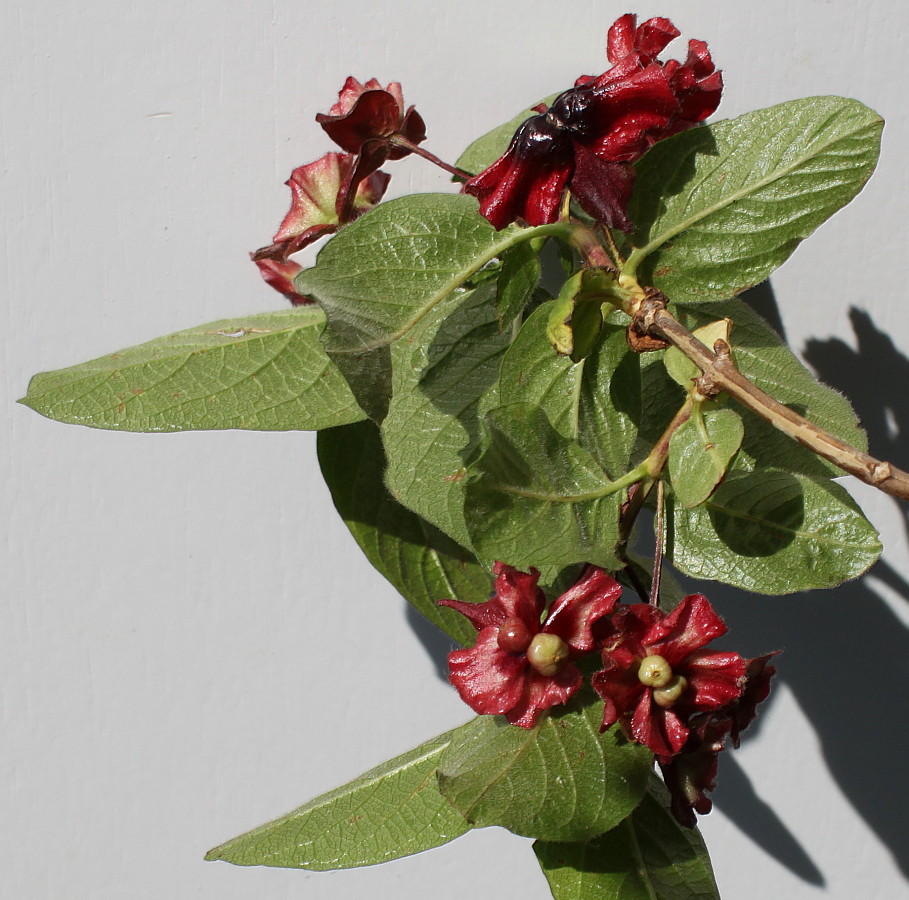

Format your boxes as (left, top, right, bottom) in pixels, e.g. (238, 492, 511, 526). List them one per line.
(465, 403, 622, 569)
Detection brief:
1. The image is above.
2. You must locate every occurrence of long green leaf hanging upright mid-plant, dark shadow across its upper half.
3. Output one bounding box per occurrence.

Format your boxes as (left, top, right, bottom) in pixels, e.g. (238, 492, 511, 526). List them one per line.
(382, 283, 510, 546)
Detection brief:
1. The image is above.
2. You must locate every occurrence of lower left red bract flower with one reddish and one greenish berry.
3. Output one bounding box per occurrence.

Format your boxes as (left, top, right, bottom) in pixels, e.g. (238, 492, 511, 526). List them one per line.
(440, 563, 621, 728)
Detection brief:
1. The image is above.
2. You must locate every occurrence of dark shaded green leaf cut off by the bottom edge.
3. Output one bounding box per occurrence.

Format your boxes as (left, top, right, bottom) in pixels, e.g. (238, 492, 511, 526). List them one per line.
(533, 775, 720, 900)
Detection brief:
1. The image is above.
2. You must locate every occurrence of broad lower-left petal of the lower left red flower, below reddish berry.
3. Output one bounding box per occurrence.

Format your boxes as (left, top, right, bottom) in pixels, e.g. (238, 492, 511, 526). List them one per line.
(448, 628, 535, 715)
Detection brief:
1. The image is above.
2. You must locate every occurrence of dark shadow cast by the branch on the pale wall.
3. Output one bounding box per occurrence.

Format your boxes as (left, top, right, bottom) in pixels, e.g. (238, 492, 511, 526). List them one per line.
(407, 282, 909, 885)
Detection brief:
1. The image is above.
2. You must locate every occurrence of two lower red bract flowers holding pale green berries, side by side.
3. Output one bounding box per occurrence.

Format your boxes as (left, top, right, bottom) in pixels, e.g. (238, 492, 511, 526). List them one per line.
(440, 563, 774, 825)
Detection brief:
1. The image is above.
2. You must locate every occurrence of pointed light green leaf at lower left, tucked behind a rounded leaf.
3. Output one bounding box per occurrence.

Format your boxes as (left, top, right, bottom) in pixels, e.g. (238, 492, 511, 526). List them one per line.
(205, 729, 470, 870)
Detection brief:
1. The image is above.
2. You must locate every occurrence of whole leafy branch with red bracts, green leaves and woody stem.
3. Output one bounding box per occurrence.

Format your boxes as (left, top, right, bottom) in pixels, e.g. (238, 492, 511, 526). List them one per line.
(23, 14, 892, 900)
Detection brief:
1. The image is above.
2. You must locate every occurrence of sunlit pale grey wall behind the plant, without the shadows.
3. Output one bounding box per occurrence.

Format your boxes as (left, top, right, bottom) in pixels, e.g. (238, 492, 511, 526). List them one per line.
(0, 0, 909, 900)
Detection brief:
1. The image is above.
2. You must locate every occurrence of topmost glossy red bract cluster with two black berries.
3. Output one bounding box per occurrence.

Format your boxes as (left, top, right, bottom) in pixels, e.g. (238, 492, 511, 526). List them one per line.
(464, 13, 723, 231)
